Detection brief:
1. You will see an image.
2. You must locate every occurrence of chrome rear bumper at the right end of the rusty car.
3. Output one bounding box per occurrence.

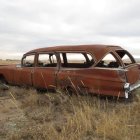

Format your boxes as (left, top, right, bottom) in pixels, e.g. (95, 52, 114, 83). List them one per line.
(124, 80, 140, 98)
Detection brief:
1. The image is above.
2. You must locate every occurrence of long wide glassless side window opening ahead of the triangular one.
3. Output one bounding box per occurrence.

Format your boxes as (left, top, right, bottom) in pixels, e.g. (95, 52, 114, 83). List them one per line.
(60, 52, 94, 68)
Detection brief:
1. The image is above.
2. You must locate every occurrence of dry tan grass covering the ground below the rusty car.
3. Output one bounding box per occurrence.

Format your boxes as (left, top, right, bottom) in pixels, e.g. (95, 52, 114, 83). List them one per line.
(0, 87, 140, 140)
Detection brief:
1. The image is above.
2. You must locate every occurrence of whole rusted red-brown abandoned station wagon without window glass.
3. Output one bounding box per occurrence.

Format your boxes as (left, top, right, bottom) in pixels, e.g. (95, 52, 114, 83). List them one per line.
(0, 45, 140, 98)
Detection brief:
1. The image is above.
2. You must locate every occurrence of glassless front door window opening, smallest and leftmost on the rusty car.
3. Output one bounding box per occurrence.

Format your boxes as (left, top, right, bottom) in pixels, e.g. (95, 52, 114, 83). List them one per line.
(22, 54, 35, 67)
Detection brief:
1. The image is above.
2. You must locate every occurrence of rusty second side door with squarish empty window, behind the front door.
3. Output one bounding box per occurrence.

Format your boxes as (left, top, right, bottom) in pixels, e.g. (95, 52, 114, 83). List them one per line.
(33, 52, 58, 89)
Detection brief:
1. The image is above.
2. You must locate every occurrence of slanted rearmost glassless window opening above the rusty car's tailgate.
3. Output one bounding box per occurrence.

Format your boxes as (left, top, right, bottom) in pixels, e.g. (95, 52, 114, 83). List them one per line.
(116, 50, 135, 66)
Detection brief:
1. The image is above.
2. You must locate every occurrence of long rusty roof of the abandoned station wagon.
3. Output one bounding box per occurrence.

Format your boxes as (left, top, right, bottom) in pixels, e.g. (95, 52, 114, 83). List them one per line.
(26, 44, 123, 61)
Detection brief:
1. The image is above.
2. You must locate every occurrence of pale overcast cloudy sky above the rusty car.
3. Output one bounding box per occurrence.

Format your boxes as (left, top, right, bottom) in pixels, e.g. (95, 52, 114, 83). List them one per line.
(0, 0, 140, 59)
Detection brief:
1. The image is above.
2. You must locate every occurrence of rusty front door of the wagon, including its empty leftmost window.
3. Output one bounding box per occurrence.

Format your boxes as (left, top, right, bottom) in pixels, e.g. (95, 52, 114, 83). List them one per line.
(14, 54, 35, 86)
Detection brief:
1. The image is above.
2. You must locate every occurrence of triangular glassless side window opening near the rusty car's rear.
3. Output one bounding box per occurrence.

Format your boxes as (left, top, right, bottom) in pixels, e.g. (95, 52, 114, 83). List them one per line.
(96, 53, 120, 68)
